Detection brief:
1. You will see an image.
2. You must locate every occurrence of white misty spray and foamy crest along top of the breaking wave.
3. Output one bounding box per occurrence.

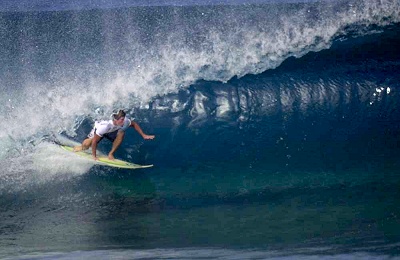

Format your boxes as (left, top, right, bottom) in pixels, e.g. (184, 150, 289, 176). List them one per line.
(0, 1, 399, 139)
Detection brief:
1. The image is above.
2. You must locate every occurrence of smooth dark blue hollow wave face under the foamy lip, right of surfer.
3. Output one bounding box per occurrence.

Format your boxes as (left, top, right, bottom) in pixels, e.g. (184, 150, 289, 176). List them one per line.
(150, 24, 399, 169)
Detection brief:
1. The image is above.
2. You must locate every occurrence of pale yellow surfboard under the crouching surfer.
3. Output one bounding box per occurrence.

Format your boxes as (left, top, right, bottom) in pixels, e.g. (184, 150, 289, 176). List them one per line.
(59, 144, 153, 169)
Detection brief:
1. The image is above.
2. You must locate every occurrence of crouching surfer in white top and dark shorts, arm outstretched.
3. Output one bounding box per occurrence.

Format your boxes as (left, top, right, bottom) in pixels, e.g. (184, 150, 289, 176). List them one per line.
(74, 110, 155, 160)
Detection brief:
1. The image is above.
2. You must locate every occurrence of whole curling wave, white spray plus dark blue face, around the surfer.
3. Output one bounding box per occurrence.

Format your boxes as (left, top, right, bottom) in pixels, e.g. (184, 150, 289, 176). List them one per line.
(0, 1, 399, 189)
